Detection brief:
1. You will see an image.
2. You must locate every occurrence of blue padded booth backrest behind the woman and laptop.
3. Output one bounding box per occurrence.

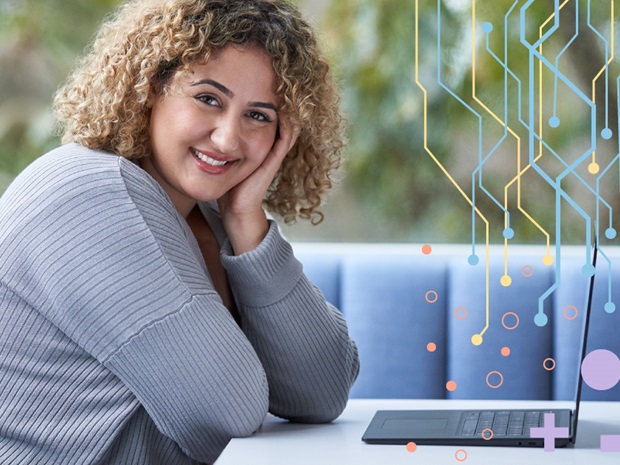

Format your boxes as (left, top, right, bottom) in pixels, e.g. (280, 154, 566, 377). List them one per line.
(293, 243, 620, 400)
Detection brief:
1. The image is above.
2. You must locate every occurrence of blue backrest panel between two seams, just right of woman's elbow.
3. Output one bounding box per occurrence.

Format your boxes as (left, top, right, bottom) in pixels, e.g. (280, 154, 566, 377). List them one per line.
(341, 253, 446, 398)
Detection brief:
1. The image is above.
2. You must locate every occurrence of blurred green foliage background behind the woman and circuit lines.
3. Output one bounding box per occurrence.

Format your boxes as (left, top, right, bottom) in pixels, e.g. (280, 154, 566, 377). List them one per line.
(0, 0, 620, 243)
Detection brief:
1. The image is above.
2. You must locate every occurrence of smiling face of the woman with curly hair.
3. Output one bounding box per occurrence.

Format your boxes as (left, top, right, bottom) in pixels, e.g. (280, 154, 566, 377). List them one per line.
(141, 46, 278, 216)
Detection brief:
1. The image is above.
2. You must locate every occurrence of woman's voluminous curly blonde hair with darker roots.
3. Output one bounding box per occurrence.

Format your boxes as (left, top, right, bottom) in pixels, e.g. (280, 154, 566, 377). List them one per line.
(54, 0, 345, 224)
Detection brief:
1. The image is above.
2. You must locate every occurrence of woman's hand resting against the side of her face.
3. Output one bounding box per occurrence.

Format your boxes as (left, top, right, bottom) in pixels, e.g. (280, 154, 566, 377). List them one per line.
(218, 118, 300, 255)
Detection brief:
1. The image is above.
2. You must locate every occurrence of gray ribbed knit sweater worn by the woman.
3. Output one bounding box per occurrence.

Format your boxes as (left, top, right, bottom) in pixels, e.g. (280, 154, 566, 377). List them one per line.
(0, 144, 359, 465)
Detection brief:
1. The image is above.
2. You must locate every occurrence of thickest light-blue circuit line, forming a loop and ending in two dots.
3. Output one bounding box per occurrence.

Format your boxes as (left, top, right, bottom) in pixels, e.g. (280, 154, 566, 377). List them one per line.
(520, 0, 596, 326)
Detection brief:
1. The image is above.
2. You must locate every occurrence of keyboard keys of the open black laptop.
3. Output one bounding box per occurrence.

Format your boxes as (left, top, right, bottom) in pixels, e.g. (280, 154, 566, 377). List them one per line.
(460, 410, 544, 439)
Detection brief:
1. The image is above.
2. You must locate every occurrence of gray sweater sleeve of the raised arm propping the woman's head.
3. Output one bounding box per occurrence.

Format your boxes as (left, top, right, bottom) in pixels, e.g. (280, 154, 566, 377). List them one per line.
(222, 222, 359, 422)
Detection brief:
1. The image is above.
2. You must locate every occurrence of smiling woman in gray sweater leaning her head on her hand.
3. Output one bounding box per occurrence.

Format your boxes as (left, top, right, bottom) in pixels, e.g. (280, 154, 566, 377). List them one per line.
(0, 0, 359, 465)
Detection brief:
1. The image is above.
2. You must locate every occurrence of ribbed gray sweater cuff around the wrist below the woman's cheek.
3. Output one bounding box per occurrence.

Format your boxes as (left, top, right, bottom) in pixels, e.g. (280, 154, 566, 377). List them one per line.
(221, 220, 302, 307)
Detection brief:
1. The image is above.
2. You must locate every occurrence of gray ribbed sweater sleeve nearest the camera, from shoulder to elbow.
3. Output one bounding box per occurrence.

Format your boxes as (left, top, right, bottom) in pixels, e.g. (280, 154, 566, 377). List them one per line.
(2, 146, 268, 462)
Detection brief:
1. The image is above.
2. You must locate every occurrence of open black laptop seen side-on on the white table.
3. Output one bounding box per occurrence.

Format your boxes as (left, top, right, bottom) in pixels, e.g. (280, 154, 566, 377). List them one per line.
(362, 243, 598, 447)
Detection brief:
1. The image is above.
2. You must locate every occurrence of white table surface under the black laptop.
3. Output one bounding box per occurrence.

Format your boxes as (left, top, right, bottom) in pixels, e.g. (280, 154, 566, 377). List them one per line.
(216, 399, 620, 465)
